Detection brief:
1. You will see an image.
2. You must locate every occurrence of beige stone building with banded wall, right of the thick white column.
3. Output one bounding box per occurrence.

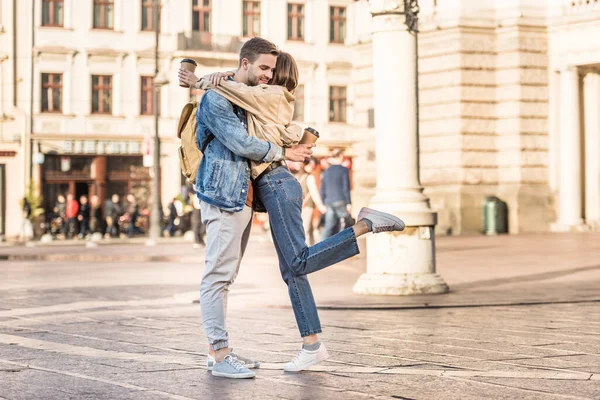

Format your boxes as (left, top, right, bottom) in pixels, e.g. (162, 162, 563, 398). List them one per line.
(354, 0, 600, 234)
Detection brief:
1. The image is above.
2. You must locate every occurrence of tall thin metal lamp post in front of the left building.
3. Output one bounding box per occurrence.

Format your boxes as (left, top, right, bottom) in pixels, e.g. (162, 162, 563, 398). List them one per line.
(150, 0, 162, 243)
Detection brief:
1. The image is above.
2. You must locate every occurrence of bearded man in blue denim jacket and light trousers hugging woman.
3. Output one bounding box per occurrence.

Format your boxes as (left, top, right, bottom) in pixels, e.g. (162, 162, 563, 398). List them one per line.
(179, 38, 312, 378)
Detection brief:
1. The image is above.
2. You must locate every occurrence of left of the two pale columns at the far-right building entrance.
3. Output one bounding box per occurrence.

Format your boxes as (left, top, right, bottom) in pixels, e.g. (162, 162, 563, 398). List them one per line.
(557, 67, 582, 231)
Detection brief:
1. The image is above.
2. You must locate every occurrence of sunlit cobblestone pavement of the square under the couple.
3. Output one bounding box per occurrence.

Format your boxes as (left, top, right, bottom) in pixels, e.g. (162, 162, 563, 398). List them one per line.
(0, 234, 600, 400)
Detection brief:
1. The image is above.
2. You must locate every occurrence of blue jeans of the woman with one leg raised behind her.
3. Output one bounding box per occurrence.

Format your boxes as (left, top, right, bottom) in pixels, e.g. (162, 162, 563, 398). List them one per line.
(255, 166, 359, 337)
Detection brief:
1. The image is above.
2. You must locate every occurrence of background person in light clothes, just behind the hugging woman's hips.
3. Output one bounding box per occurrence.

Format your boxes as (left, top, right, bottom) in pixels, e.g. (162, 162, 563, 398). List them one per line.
(296, 157, 327, 246)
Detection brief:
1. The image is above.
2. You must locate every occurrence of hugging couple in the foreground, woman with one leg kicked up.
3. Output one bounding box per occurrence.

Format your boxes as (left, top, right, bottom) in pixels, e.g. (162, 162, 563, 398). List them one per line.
(179, 38, 404, 378)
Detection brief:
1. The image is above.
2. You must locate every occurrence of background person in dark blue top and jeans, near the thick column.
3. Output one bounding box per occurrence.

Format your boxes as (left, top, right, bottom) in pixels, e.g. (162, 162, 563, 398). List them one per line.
(321, 149, 352, 240)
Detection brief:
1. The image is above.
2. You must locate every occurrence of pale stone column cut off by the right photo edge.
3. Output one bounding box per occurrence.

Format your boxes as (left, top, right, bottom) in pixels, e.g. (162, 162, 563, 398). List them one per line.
(583, 71, 600, 227)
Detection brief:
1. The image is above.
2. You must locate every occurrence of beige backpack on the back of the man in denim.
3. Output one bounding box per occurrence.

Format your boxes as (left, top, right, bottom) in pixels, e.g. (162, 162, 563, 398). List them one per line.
(177, 101, 214, 184)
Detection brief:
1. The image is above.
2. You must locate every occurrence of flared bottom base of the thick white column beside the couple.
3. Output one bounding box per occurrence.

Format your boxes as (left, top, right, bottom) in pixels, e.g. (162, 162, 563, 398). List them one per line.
(352, 272, 449, 296)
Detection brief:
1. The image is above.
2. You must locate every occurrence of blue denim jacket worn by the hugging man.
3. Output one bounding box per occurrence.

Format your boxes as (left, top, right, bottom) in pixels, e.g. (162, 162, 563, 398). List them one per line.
(196, 90, 284, 211)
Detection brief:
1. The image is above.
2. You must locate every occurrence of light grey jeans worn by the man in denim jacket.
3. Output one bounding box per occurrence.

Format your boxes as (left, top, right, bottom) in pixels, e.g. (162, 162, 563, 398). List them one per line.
(200, 202, 252, 350)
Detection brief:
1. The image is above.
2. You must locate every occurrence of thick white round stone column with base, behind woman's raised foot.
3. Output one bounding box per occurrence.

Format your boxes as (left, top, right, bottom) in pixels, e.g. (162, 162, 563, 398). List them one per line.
(354, 0, 448, 295)
